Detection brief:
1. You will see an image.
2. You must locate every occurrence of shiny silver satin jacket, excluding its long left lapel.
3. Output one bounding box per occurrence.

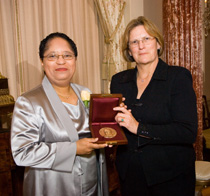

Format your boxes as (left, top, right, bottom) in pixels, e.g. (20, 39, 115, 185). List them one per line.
(11, 76, 108, 196)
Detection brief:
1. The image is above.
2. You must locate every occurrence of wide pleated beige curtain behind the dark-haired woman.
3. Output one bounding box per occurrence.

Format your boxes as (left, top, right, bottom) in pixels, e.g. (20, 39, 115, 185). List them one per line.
(0, 0, 101, 98)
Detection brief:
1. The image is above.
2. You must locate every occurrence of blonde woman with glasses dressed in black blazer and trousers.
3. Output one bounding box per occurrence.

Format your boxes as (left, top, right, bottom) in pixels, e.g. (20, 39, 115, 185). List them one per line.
(111, 16, 197, 196)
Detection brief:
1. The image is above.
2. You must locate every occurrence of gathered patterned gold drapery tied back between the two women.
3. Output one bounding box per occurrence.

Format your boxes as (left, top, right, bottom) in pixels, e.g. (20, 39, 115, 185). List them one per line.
(94, 0, 127, 93)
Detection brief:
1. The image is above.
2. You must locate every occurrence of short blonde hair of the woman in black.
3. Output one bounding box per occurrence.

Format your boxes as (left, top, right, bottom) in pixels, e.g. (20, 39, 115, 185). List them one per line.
(122, 16, 164, 62)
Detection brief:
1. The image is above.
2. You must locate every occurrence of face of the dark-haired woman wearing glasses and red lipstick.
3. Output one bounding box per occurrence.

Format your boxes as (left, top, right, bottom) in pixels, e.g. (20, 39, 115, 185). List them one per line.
(42, 37, 76, 86)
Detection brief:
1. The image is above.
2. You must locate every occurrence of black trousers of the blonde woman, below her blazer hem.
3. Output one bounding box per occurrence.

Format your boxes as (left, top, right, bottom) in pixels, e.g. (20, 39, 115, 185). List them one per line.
(120, 155, 195, 196)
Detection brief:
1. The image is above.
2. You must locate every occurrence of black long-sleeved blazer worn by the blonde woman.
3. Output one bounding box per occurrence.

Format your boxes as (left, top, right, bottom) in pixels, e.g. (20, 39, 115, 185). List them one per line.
(111, 59, 197, 185)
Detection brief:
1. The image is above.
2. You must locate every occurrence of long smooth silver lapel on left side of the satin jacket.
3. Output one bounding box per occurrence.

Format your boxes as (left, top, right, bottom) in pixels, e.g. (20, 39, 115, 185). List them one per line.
(42, 76, 78, 141)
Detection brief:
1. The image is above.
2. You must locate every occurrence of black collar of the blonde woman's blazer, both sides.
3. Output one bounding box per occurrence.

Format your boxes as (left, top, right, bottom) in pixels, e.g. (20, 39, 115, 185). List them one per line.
(122, 58, 168, 83)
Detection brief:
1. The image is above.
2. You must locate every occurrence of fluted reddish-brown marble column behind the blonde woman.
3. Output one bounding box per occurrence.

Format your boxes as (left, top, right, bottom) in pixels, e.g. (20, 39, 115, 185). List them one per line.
(163, 0, 203, 160)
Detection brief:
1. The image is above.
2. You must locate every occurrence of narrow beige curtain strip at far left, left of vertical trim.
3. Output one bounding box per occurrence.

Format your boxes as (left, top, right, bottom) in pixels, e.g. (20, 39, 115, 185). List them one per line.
(0, 0, 18, 96)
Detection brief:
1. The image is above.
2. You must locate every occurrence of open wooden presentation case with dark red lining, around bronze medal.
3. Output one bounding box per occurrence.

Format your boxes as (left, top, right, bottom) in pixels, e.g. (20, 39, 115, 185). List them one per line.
(89, 94, 128, 145)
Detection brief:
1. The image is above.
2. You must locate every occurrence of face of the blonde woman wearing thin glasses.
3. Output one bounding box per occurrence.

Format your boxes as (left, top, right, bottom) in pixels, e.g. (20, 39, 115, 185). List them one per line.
(129, 25, 160, 65)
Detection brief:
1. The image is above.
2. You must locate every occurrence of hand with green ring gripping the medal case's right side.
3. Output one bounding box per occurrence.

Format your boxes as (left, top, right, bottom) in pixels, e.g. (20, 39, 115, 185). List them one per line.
(113, 105, 139, 134)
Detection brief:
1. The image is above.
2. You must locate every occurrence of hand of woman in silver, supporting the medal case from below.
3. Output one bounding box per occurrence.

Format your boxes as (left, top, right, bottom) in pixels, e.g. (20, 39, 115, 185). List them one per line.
(76, 138, 107, 155)
